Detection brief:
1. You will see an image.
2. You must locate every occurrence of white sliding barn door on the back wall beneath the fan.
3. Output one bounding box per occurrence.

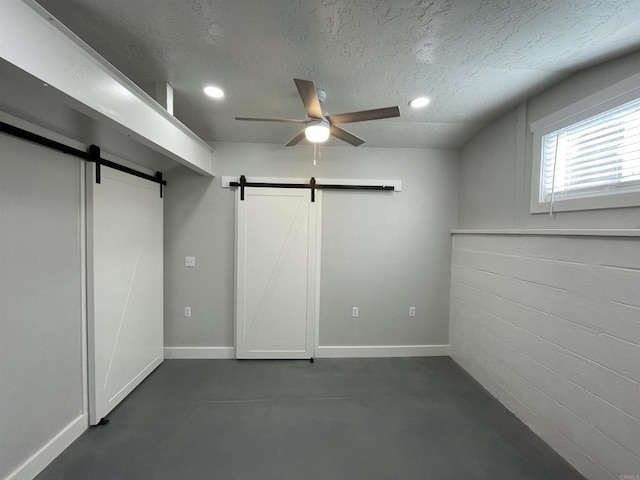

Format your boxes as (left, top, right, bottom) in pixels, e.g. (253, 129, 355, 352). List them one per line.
(236, 187, 320, 358)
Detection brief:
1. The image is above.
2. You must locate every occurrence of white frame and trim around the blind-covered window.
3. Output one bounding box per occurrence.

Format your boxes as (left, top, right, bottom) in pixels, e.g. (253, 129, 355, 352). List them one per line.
(529, 74, 640, 213)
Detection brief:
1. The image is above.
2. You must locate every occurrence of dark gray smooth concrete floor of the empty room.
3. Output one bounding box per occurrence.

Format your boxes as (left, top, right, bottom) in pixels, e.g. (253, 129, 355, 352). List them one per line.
(37, 357, 583, 480)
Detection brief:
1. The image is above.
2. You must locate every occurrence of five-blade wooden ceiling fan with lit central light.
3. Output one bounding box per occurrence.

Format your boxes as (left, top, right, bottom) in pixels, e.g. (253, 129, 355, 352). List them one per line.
(235, 78, 400, 147)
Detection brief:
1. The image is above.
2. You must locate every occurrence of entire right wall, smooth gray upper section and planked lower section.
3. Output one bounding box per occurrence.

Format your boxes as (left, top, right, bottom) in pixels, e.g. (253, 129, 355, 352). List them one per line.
(450, 49, 640, 479)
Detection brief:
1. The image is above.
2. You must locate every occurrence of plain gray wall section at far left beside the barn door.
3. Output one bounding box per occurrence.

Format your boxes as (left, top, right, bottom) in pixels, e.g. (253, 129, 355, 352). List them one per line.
(0, 135, 86, 478)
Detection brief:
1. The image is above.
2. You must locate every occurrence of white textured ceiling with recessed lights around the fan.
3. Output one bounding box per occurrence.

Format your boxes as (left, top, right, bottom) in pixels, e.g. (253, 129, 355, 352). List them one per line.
(32, 0, 640, 148)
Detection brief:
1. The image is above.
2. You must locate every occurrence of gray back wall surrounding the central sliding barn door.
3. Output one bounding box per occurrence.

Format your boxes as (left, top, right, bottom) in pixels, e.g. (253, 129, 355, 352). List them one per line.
(165, 143, 458, 356)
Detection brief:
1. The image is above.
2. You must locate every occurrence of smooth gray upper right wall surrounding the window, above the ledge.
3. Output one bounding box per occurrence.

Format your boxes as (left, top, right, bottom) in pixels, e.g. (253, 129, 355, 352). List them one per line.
(458, 49, 640, 229)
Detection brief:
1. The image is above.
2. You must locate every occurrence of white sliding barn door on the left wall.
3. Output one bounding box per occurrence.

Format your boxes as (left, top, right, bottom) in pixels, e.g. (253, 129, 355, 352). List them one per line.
(87, 164, 163, 425)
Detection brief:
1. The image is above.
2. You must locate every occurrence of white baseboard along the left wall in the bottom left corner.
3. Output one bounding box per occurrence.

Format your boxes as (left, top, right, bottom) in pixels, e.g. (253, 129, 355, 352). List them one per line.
(5, 413, 89, 480)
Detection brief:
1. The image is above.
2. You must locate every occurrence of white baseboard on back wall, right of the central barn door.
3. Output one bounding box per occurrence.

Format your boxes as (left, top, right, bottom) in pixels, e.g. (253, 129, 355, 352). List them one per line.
(315, 345, 449, 358)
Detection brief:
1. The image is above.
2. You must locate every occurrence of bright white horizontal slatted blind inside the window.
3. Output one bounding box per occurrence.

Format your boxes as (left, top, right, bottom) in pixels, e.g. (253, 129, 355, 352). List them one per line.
(540, 99, 640, 204)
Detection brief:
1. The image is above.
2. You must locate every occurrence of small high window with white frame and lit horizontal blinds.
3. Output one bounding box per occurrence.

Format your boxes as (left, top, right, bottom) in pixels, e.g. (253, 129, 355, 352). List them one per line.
(531, 71, 640, 213)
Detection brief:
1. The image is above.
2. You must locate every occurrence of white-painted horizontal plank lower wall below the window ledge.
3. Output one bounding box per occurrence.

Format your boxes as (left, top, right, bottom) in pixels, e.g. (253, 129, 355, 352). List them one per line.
(450, 234, 640, 479)
